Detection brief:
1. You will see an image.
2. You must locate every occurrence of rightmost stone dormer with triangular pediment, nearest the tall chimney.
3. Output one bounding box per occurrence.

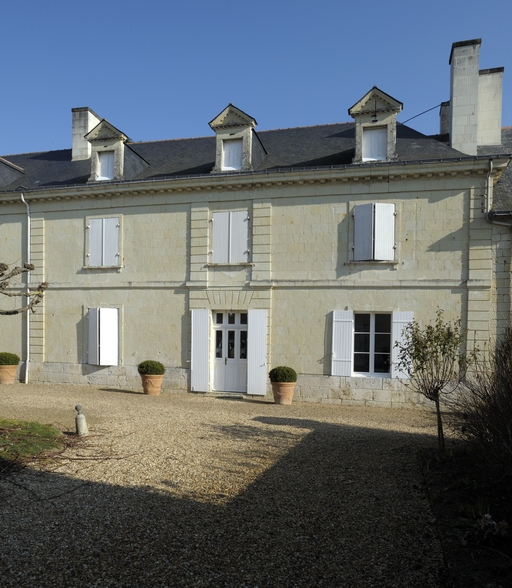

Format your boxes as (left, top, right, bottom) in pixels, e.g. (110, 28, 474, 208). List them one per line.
(348, 86, 403, 163)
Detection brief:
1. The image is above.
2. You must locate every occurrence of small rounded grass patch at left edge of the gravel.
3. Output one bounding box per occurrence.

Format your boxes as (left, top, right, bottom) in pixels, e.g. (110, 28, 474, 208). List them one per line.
(0, 418, 64, 462)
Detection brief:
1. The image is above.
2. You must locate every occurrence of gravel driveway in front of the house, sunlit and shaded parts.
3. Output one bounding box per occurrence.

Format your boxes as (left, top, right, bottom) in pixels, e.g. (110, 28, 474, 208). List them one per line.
(0, 384, 443, 588)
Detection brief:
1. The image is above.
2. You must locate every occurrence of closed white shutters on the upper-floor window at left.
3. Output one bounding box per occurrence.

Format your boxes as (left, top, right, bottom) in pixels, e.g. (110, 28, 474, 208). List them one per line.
(85, 215, 122, 268)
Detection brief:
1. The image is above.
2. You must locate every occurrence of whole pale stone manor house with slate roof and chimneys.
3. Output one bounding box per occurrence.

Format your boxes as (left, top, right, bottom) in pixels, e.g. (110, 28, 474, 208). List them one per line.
(0, 39, 512, 406)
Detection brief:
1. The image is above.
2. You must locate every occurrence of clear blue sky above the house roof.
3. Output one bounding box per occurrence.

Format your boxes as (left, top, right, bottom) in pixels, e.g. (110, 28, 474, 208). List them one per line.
(0, 0, 512, 155)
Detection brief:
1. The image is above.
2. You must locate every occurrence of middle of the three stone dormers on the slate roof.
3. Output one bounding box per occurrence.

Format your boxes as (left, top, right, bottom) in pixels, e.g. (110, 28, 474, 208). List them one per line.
(209, 104, 266, 173)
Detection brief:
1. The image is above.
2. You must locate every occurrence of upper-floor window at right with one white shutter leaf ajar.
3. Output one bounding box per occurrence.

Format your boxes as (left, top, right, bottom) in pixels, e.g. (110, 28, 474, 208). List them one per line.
(353, 203, 395, 261)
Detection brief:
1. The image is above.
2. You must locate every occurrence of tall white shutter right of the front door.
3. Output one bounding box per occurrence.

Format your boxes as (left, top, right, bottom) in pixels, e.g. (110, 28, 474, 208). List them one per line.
(247, 310, 267, 396)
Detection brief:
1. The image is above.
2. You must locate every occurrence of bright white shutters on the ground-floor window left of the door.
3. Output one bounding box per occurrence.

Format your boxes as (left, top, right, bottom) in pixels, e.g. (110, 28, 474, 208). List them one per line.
(87, 308, 120, 366)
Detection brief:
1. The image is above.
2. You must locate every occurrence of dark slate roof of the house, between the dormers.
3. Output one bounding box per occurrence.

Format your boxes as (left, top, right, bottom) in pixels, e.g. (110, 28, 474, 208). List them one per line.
(0, 122, 512, 202)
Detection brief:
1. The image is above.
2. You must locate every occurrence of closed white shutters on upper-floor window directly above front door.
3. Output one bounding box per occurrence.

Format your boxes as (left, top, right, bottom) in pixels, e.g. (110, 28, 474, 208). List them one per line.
(211, 211, 249, 264)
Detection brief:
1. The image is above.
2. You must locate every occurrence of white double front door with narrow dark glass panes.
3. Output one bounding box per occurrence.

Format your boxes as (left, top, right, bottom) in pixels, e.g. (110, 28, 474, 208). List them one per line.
(213, 311, 247, 392)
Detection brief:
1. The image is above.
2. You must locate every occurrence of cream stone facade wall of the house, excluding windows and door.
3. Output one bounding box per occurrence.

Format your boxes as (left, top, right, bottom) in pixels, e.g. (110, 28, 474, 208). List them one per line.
(0, 154, 510, 406)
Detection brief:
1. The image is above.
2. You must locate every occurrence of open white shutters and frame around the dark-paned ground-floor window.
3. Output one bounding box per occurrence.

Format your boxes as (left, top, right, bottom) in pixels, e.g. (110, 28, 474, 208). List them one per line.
(331, 310, 414, 379)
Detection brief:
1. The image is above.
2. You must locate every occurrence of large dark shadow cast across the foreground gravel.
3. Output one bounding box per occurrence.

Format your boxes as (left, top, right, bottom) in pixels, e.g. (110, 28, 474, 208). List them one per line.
(0, 417, 443, 588)
